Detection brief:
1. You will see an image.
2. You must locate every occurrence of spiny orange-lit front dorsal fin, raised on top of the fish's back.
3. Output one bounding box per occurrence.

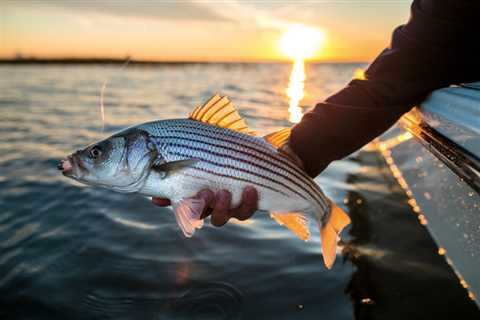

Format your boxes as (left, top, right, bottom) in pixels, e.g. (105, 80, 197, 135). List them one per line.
(189, 94, 255, 135)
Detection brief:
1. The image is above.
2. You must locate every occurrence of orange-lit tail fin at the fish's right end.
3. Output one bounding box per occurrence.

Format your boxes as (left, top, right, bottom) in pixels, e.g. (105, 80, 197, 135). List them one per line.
(319, 203, 350, 269)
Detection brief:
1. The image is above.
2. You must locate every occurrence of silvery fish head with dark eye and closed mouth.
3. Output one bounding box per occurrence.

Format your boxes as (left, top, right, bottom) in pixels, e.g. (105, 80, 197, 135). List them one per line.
(58, 128, 158, 192)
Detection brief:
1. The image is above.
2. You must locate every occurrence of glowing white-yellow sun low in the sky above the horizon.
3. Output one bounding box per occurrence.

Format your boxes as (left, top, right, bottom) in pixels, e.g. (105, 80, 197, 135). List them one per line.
(280, 24, 325, 60)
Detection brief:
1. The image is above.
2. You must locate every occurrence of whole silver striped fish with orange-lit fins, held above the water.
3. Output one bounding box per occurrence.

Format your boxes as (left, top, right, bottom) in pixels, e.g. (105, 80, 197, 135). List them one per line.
(59, 95, 350, 268)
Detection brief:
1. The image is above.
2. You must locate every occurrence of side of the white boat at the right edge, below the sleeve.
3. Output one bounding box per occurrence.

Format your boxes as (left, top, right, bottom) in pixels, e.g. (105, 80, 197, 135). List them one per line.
(378, 83, 480, 306)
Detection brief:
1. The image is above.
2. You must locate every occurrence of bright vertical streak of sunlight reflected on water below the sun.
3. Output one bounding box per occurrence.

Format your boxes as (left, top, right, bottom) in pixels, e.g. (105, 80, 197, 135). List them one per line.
(286, 58, 306, 123)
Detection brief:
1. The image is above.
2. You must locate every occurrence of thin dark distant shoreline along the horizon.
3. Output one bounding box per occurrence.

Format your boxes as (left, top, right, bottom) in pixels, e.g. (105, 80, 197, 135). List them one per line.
(0, 58, 367, 65)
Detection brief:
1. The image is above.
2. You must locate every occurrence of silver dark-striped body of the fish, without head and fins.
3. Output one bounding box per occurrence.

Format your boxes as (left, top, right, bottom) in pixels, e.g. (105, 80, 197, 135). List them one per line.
(136, 119, 329, 218)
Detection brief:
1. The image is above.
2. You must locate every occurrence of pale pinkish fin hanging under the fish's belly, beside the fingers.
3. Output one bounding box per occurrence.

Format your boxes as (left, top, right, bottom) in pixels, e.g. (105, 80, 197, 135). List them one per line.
(172, 198, 205, 238)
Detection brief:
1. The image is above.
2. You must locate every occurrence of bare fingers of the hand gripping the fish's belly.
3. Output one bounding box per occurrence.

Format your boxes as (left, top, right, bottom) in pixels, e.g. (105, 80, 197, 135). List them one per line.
(152, 186, 258, 227)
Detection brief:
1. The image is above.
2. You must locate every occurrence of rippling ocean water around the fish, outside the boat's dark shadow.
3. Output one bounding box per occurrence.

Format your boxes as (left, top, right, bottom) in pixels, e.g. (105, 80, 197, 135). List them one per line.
(0, 64, 478, 319)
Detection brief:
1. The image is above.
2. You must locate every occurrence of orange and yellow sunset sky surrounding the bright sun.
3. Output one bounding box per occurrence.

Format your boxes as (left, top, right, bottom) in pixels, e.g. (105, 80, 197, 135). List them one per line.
(0, 0, 410, 61)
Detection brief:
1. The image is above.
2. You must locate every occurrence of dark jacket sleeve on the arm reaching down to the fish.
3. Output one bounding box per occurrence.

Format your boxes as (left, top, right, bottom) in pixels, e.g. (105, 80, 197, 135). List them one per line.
(289, 0, 480, 176)
